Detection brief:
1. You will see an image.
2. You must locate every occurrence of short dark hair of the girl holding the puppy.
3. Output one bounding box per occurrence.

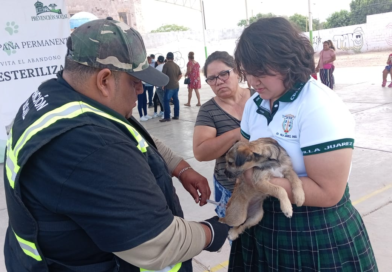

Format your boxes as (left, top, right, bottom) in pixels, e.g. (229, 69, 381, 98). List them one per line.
(234, 17, 315, 89)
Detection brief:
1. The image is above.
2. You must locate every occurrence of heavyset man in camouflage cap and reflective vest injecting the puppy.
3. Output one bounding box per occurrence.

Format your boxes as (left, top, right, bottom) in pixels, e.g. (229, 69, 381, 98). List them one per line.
(4, 18, 228, 272)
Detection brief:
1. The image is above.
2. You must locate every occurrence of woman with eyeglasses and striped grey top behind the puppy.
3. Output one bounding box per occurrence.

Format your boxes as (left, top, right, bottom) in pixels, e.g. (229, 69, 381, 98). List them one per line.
(193, 51, 254, 217)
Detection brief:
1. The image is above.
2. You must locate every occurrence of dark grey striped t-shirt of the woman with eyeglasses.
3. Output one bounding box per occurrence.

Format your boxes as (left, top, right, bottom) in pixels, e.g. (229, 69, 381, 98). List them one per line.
(195, 90, 254, 192)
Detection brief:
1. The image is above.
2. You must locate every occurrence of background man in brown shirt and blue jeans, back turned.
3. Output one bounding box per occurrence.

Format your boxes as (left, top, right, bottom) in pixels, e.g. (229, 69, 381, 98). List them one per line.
(159, 52, 182, 122)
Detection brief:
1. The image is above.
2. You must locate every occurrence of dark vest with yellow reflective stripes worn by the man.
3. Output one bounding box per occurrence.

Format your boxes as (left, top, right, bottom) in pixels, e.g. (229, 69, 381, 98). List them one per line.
(4, 75, 185, 272)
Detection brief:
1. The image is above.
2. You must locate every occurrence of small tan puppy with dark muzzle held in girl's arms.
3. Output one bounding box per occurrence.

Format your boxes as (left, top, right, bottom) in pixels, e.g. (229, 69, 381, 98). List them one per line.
(220, 138, 305, 240)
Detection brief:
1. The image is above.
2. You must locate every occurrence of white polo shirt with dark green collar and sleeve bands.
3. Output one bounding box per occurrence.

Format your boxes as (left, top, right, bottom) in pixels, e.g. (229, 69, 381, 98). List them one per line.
(241, 78, 355, 176)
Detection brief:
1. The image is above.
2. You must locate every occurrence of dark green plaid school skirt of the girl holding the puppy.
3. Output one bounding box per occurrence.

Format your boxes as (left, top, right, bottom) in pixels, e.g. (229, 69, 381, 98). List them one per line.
(229, 186, 378, 272)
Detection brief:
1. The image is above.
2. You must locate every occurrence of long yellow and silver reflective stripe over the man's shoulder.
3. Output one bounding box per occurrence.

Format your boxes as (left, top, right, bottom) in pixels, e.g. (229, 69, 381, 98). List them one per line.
(6, 102, 148, 189)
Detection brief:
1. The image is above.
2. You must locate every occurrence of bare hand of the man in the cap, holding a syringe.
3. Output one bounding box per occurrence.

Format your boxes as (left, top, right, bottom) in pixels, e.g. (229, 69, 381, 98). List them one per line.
(180, 168, 211, 206)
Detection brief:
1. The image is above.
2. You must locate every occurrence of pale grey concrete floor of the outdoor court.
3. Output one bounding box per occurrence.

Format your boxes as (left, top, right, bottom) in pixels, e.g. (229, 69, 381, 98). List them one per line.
(0, 66, 392, 272)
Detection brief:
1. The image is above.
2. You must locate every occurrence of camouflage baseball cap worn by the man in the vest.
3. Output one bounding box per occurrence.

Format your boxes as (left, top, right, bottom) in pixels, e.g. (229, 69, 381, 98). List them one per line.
(67, 17, 169, 86)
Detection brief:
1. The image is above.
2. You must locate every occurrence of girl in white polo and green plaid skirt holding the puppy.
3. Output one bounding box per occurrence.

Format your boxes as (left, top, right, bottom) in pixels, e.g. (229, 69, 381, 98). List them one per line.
(228, 17, 378, 272)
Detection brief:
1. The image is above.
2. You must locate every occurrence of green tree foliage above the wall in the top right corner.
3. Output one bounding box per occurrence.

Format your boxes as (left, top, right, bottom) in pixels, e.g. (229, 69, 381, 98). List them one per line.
(350, 0, 392, 25)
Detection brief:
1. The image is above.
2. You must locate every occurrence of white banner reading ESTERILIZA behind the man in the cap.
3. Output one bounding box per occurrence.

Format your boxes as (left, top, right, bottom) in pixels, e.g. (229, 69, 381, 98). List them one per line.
(0, 0, 70, 163)
